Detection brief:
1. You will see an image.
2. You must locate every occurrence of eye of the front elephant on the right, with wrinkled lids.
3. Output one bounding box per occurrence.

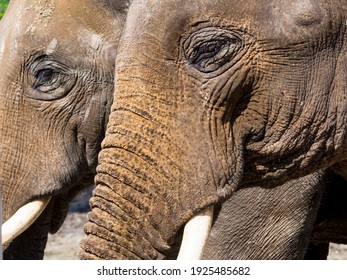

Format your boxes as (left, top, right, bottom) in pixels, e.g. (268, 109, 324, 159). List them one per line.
(183, 27, 242, 73)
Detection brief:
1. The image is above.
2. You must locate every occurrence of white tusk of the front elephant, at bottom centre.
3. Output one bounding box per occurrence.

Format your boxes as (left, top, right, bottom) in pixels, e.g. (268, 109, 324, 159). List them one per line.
(177, 206, 213, 260)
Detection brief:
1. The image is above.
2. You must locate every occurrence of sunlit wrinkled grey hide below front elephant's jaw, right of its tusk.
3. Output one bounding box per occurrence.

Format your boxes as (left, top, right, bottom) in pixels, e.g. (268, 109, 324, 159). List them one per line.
(204, 174, 325, 260)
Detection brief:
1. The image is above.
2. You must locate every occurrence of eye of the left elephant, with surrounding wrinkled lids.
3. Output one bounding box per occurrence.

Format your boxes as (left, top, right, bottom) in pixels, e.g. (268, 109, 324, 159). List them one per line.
(30, 61, 76, 100)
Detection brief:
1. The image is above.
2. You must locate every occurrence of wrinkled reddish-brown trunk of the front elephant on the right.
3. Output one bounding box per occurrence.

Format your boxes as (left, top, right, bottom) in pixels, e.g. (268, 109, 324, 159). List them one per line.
(80, 56, 230, 259)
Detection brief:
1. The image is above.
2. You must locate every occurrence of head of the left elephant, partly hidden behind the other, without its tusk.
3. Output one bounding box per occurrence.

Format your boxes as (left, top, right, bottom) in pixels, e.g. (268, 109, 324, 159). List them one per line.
(0, 0, 127, 259)
